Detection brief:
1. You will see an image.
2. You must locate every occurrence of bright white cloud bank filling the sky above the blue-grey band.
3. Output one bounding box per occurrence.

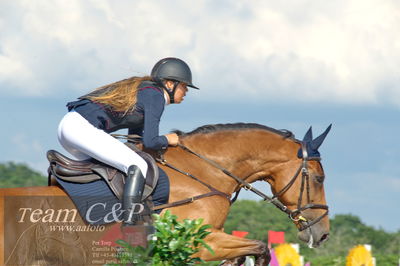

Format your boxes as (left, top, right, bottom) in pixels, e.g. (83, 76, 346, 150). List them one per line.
(0, 0, 400, 106)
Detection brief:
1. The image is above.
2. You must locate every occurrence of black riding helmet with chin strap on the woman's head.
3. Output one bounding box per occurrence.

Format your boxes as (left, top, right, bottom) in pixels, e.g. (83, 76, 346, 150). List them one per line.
(150, 57, 199, 103)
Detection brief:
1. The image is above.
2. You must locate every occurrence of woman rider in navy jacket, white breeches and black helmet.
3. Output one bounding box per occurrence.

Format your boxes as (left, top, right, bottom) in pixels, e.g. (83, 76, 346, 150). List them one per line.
(58, 57, 198, 225)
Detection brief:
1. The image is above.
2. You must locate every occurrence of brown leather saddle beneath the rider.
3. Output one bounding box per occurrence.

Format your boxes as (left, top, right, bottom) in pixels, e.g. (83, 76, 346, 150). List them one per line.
(47, 142, 159, 200)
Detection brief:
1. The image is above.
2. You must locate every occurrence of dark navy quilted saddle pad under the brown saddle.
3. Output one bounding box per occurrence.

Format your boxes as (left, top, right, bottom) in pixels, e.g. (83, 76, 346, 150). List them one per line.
(57, 168, 169, 225)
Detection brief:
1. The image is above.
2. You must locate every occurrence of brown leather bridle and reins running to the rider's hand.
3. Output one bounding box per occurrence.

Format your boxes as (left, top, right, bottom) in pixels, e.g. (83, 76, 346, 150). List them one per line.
(178, 141, 328, 231)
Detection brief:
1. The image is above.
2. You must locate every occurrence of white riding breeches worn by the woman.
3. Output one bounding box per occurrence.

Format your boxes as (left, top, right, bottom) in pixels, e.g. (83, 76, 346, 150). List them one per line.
(58, 111, 147, 177)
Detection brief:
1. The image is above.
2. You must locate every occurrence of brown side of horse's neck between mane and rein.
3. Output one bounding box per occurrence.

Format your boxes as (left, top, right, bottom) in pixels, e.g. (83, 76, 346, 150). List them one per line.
(179, 130, 295, 189)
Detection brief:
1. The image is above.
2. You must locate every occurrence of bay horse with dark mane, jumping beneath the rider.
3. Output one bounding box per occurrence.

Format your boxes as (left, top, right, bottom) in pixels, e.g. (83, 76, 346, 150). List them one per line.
(0, 123, 331, 265)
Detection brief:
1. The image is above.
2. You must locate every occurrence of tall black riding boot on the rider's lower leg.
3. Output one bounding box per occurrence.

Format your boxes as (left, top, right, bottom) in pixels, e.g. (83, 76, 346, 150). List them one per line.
(122, 165, 148, 225)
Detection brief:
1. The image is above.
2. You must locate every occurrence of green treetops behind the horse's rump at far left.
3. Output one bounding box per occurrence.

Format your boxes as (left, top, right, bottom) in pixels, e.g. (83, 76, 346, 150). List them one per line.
(0, 162, 47, 188)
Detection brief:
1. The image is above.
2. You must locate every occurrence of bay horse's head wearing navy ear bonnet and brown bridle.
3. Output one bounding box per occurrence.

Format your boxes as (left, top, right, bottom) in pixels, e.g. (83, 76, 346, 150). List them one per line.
(267, 126, 331, 247)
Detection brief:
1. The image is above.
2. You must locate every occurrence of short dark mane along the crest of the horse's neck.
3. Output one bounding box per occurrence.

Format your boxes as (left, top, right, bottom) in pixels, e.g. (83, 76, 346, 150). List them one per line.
(173, 123, 294, 139)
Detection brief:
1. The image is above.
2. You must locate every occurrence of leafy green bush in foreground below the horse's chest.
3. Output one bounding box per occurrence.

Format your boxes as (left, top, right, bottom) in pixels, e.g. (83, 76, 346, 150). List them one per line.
(111, 211, 213, 266)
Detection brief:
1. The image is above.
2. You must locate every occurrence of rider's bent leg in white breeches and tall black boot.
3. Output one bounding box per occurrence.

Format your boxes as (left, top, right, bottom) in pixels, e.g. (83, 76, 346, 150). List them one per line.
(58, 112, 147, 224)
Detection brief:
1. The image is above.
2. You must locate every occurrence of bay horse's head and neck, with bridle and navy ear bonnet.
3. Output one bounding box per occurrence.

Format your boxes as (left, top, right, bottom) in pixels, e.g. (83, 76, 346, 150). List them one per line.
(170, 123, 330, 247)
